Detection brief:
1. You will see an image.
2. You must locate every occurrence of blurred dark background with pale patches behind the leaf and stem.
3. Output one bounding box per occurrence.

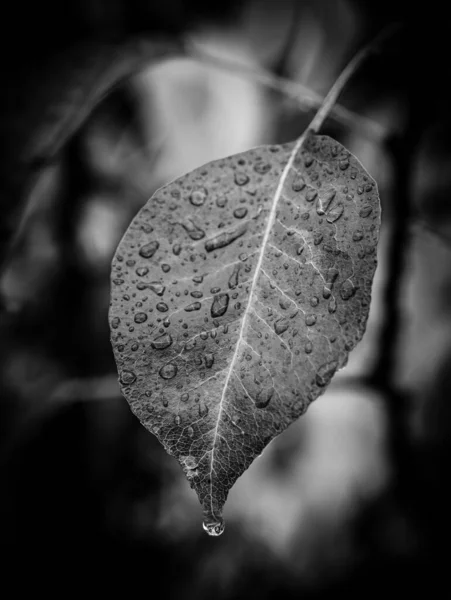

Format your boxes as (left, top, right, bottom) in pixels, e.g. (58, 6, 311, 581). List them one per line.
(0, 0, 451, 600)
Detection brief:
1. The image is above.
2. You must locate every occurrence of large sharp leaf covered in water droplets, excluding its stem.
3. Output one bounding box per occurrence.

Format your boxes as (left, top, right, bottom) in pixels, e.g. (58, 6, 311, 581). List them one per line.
(110, 127, 380, 535)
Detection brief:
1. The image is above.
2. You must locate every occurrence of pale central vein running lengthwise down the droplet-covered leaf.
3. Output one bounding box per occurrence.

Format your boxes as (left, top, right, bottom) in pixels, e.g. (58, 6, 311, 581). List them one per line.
(210, 129, 309, 516)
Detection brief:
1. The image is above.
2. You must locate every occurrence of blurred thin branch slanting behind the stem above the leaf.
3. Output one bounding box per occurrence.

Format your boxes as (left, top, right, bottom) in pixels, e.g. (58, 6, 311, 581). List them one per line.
(185, 40, 388, 141)
